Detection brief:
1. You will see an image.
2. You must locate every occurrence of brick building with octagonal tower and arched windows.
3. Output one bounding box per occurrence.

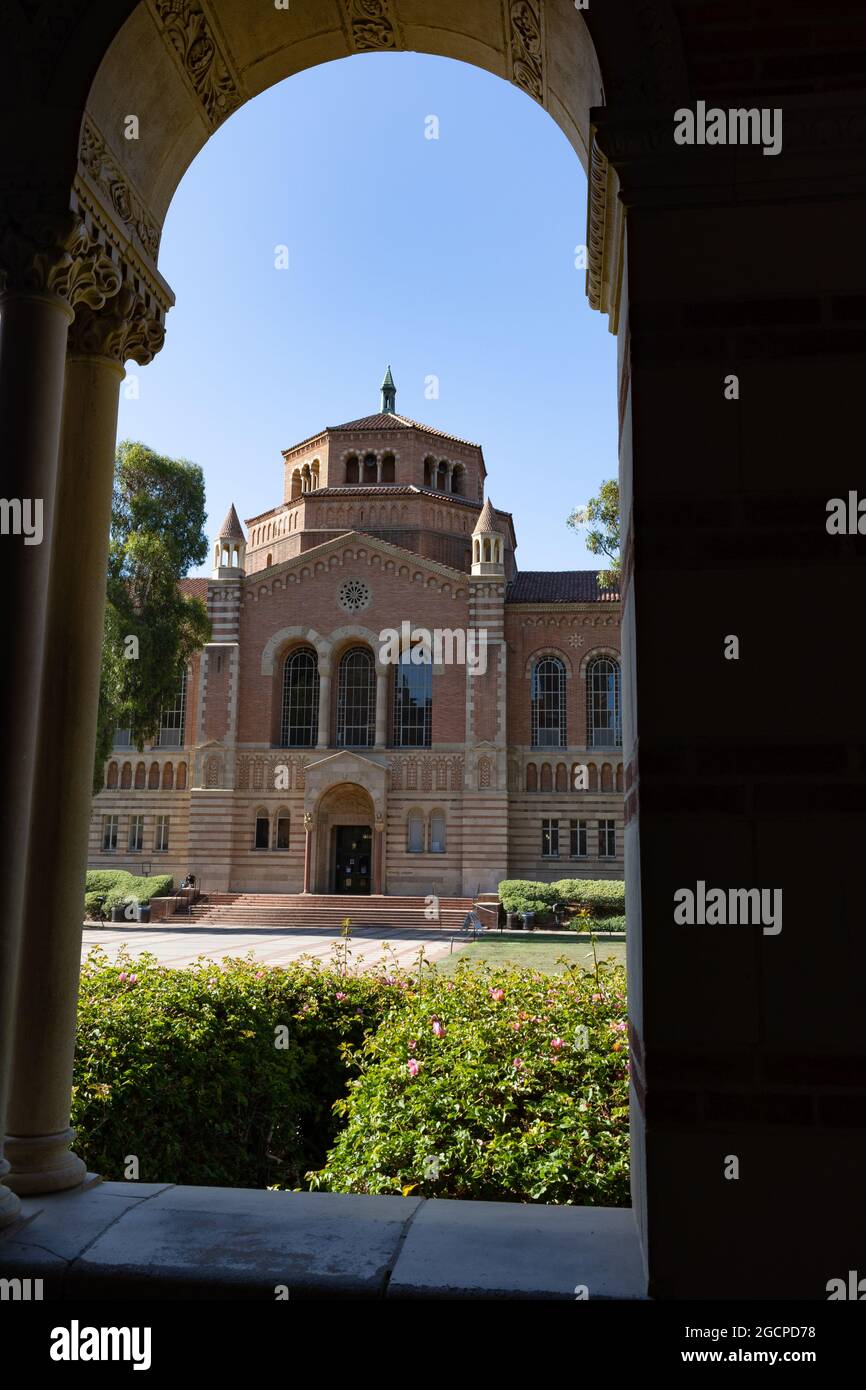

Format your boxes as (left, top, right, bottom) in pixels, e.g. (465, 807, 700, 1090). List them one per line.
(89, 371, 623, 895)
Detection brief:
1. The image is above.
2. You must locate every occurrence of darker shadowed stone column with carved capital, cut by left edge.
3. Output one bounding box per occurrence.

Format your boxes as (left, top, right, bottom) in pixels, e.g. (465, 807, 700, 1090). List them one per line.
(0, 211, 120, 1226)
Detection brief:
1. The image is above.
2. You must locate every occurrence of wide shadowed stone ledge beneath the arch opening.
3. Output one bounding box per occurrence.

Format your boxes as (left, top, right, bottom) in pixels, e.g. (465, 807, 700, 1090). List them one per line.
(0, 1183, 646, 1301)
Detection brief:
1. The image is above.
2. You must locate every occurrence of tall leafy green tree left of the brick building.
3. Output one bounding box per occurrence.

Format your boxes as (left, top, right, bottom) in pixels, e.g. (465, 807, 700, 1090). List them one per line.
(93, 439, 210, 791)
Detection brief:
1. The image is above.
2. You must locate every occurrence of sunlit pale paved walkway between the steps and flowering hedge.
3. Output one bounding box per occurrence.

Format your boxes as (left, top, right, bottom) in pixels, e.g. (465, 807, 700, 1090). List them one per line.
(81, 923, 463, 966)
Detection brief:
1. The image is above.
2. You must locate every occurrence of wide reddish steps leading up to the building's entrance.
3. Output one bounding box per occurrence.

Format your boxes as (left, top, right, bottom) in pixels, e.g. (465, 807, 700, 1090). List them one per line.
(176, 892, 473, 931)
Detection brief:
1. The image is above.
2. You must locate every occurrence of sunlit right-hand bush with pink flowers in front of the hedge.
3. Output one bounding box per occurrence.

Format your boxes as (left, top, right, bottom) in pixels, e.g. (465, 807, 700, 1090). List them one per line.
(307, 960, 628, 1207)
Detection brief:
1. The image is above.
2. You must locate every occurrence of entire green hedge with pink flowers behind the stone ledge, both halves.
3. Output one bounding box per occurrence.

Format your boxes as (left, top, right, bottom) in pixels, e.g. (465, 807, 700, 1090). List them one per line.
(72, 948, 628, 1205)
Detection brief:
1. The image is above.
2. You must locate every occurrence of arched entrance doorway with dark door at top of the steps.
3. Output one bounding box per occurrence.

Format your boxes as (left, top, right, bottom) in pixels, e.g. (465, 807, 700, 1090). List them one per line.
(313, 783, 377, 897)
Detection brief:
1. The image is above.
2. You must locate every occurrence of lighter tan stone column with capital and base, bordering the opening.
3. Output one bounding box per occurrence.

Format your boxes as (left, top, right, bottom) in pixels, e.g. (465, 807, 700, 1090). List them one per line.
(6, 291, 163, 1194)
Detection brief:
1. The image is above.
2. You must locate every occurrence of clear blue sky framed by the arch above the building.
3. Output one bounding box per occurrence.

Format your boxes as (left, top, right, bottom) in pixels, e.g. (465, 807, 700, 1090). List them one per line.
(120, 53, 617, 573)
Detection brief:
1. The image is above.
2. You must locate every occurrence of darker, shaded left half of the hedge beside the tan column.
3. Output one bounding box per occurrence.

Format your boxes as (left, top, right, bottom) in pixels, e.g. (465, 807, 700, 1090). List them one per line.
(72, 951, 399, 1187)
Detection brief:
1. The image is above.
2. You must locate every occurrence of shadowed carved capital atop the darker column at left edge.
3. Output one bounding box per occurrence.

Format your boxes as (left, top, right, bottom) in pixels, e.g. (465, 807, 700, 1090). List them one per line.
(0, 211, 121, 309)
